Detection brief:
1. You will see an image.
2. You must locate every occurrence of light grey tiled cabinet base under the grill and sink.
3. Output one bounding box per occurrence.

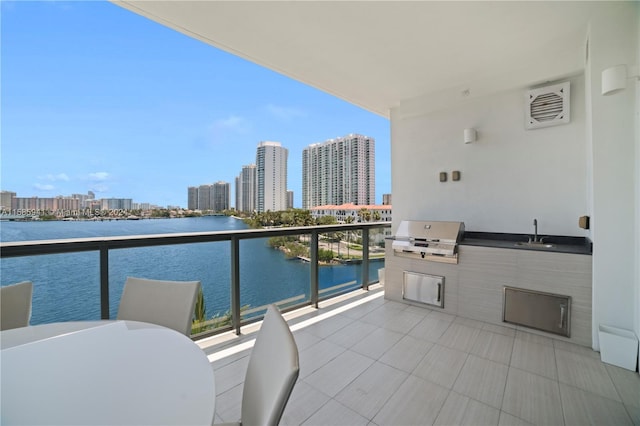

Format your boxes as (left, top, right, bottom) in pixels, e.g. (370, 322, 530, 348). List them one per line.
(385, 244, 592, 347)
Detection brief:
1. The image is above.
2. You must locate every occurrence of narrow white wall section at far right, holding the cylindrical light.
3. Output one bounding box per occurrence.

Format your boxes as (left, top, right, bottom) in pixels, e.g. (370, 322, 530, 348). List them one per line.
(586, 2, 640, 349)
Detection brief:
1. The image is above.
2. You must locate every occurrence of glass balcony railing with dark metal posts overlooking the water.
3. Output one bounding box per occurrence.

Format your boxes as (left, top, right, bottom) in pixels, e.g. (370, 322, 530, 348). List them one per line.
(0, 223, 390, 338)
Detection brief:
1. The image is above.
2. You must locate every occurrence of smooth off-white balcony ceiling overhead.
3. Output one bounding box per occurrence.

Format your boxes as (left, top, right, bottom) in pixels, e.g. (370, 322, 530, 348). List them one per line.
(114, 0, 615, 117)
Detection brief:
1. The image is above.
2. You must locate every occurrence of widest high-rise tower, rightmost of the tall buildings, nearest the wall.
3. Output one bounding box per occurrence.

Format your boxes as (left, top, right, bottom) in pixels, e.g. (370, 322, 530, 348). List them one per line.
(302, 134, 376, 209)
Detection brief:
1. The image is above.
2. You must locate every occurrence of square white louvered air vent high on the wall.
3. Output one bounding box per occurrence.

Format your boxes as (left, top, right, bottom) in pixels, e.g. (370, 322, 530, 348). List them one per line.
(525, 81, 569, 129)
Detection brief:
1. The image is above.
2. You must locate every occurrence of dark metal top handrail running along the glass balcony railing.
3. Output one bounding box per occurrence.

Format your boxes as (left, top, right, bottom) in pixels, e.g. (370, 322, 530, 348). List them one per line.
(0, 222, 391, 258)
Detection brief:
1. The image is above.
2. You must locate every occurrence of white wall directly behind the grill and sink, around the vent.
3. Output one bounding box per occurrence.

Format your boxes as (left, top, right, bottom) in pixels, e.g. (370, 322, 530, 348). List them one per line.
(391, 76, 589, 236)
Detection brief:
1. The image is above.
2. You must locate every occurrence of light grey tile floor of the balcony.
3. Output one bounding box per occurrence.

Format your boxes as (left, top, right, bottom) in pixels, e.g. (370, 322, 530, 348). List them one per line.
(199, 289, 640, 426)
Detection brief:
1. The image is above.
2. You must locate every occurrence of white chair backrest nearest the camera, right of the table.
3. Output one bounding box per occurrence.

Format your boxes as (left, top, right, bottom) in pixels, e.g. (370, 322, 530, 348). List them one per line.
(241, 305, 300, 426)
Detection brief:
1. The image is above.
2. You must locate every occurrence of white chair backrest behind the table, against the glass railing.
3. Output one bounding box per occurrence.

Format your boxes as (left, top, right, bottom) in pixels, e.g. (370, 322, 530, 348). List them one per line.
(117, 277, 200, 336)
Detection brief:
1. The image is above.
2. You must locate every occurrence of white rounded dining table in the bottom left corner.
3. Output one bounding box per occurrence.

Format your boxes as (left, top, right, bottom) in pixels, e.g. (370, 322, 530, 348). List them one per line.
(0, 321, 215, 425)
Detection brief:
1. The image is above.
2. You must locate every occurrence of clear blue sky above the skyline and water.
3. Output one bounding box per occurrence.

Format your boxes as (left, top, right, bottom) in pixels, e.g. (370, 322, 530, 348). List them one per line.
(0, 0, 391, 207)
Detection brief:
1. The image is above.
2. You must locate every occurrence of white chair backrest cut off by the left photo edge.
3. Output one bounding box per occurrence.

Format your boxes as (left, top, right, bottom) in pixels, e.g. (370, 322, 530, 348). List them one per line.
(0, 281, 33, 330)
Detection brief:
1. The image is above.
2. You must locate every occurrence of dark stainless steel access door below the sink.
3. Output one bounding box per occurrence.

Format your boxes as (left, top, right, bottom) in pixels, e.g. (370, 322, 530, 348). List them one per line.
(502, 287, 571, 337)
